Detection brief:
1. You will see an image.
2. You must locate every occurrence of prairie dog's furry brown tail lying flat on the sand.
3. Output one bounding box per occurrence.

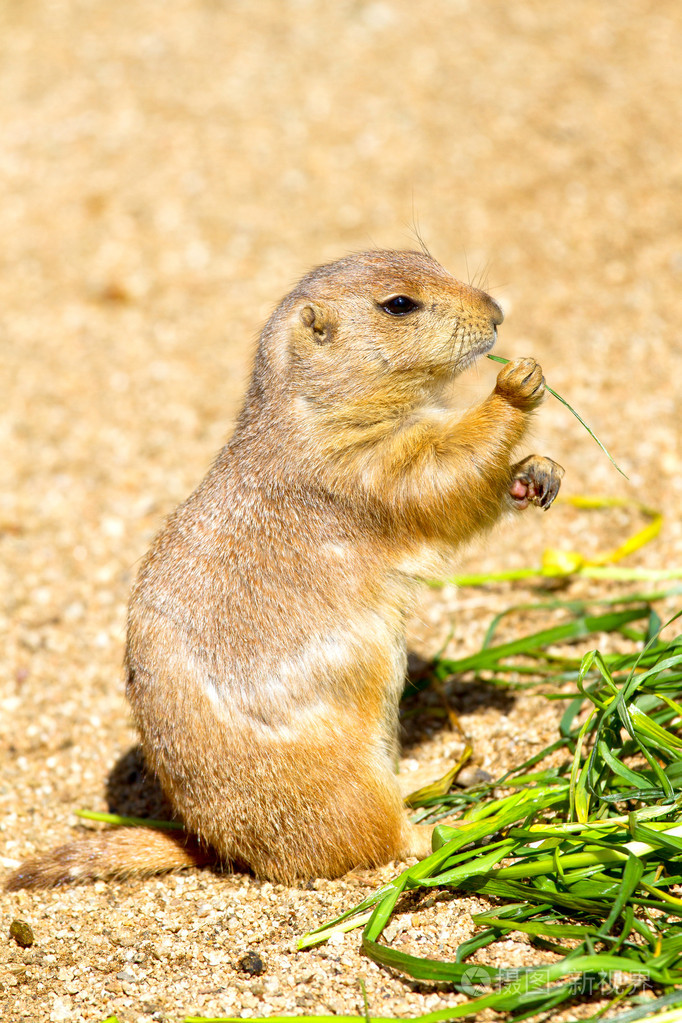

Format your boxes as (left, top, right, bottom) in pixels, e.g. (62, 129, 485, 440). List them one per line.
(5, 828, 213, 891)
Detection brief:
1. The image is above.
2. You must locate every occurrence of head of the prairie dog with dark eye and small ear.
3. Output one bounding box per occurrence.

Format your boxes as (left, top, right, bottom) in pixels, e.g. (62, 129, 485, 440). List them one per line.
(249, 251, 502, 418)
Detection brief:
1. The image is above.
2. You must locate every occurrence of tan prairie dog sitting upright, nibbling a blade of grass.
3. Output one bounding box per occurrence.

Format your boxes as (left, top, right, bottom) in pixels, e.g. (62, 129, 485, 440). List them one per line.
(9, 252, 563, 888)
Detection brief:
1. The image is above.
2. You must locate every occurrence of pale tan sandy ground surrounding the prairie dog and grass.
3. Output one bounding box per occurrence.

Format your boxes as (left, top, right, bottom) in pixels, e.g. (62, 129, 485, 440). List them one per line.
(0, 0, 682, 1023)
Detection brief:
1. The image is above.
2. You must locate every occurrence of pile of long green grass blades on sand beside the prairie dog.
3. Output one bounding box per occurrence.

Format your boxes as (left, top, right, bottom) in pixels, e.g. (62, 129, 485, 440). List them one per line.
(290, 597, 682, 1023)
